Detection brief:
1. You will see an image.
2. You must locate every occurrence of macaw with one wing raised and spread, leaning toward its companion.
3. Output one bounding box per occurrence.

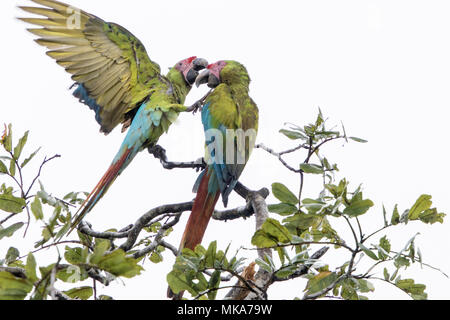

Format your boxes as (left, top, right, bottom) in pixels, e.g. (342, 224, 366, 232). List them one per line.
(20, 0, 208, 229)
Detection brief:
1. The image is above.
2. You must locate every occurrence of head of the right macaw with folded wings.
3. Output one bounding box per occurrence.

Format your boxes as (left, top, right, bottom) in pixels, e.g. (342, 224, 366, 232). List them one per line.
(195, 60, 250, 88)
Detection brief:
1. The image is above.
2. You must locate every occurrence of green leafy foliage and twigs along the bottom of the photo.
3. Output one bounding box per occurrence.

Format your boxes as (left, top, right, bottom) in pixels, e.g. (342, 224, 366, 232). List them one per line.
(0, 112, 445, 300)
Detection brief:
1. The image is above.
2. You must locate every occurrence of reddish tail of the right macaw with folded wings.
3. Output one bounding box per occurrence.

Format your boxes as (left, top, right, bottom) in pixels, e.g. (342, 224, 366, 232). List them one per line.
(180, 169, 220, 250)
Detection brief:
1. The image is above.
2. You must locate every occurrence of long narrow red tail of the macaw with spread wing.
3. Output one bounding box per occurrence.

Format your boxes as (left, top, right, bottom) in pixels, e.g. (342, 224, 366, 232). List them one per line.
(68, 149, 133, 235)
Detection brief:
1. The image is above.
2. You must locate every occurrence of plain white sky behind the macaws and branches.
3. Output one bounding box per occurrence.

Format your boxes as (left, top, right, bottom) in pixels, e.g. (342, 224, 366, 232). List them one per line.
(0, 0, 450, 299)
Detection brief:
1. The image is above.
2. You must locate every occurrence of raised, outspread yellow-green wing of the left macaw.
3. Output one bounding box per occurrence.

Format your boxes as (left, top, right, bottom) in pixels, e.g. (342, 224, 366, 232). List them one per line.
(20, 0, 162, 134)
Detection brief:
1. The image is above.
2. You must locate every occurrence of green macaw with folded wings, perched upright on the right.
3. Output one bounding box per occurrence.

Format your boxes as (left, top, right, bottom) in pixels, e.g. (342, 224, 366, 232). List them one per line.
(180, 60, 258, 250)
